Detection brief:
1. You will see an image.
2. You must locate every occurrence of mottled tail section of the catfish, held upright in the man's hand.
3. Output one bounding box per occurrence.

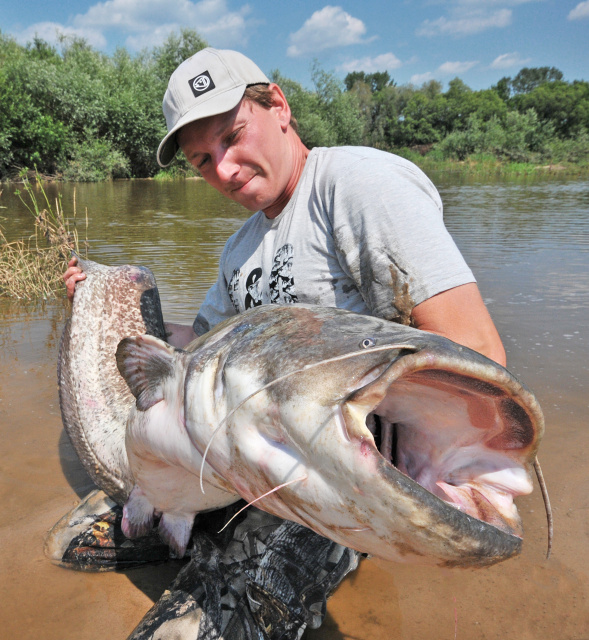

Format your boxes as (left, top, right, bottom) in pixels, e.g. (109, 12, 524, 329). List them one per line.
(58, 259, 165, 504)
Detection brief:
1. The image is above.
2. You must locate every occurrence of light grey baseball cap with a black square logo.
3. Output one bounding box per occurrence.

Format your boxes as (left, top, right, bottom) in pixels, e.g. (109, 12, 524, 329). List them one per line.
(157, 47, 270, 167)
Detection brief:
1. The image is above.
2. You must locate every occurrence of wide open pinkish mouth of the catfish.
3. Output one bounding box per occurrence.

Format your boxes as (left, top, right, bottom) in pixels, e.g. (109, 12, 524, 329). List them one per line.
(344, 349, 543, 538)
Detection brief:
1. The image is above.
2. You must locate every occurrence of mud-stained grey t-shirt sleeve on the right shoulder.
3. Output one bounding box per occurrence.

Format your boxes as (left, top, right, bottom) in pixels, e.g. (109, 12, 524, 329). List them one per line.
(331, 156, 475, 324)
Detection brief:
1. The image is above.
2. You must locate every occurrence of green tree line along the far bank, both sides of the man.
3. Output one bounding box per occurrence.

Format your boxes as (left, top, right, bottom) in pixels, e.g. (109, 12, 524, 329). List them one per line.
(0, 29, 589, 181)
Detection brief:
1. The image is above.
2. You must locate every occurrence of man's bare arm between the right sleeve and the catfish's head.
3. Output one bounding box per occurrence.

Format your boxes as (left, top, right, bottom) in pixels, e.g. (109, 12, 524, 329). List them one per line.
(411, 282, 506, 366)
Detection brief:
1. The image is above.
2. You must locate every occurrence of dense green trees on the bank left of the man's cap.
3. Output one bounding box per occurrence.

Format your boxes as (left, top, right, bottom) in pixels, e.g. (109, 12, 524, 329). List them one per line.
(0, 30, 206, 180)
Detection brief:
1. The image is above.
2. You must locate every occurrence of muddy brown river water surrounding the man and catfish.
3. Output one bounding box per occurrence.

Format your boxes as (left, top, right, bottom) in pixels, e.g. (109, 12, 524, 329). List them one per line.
(0, 176, 589, 640)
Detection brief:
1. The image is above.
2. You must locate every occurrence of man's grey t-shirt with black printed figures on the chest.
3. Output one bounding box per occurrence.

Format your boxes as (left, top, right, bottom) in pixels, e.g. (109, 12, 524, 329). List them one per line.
(194, 147, 474, 334)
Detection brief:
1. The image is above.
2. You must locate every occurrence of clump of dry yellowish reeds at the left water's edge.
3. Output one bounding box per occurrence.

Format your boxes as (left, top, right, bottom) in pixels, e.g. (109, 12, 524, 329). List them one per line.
(0, 173, 88, 300)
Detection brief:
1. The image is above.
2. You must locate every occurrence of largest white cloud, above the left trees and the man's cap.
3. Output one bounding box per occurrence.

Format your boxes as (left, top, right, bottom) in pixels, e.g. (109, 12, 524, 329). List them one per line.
(11, 0, 254, 50)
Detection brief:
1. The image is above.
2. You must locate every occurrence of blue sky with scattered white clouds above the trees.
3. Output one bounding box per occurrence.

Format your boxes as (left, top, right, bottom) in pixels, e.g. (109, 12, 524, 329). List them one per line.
(0, 0, 589, 89)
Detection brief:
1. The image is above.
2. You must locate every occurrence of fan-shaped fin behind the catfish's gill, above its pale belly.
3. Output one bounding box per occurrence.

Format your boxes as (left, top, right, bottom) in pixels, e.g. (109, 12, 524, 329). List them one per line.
(116, 335, 177, 411)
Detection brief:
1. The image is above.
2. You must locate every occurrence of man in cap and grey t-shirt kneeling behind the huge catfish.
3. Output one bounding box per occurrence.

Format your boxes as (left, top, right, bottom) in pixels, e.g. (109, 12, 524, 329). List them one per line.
(64, 48, 505, 637)
